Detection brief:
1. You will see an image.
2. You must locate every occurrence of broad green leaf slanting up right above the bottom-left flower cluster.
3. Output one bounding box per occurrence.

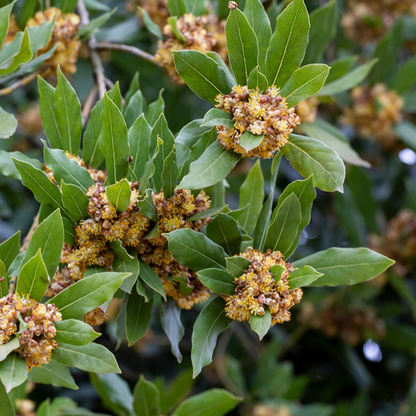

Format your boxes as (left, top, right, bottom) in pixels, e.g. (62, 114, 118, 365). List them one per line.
(48, 272, 129, 319)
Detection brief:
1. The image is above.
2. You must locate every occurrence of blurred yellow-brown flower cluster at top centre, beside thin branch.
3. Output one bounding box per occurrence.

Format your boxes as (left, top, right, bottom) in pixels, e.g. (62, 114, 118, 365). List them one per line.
(155, 13, 227, 84)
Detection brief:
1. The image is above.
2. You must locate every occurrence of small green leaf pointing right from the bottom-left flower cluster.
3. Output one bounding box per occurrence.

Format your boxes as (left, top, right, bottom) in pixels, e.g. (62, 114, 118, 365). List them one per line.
(54, 319, 101, 345)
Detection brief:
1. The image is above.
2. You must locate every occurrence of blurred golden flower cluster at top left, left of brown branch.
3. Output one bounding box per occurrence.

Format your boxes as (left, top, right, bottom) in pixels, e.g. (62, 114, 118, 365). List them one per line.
(27, 7, 81, 76)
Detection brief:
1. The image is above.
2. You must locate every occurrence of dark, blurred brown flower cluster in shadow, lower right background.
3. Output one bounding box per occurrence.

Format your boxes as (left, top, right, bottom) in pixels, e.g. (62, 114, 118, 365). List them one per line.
(299, 303, 386, 346)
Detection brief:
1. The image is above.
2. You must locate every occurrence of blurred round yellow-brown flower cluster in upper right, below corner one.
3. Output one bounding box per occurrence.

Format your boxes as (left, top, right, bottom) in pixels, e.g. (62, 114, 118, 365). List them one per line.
(341, 84, 404, 150)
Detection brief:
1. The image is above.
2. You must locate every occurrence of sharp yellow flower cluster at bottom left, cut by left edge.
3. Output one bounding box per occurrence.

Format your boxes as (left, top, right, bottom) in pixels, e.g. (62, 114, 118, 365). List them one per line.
(0, 294, 62, 371)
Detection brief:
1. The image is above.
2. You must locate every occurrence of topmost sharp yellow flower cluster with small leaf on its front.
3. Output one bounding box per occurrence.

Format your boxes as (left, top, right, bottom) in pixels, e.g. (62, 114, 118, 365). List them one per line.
(216, 85, 300, 159)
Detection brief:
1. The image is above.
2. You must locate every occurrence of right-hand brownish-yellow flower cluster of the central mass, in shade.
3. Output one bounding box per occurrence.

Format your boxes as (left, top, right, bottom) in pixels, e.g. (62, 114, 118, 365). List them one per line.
(137, 189, 211, 309)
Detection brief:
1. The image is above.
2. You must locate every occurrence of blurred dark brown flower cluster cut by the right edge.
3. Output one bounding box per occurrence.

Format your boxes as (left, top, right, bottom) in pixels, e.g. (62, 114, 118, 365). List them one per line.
(370, 209, 416, 276)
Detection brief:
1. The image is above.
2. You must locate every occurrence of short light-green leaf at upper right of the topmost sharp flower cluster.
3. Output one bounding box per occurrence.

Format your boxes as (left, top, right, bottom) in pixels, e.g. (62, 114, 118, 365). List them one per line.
(281, 64, 330, 108)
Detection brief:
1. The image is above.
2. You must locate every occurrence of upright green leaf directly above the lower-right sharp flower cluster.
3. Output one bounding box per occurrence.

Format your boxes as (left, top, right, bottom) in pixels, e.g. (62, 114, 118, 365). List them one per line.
(264, 193, 302, 258)
